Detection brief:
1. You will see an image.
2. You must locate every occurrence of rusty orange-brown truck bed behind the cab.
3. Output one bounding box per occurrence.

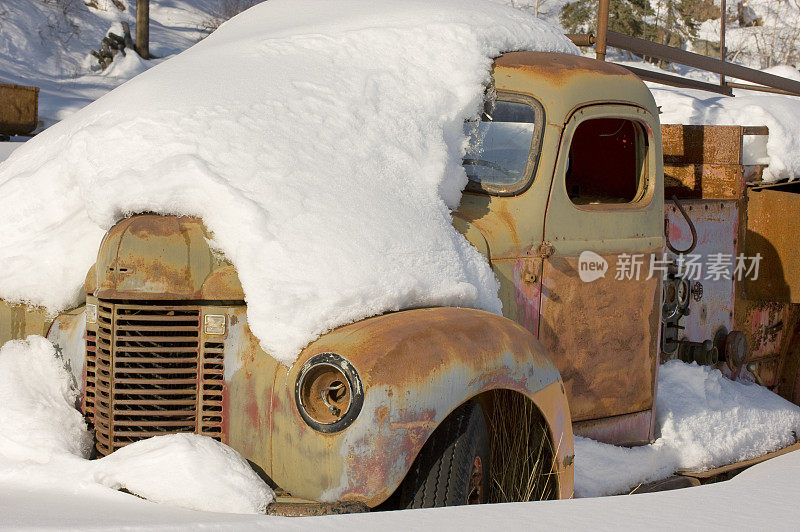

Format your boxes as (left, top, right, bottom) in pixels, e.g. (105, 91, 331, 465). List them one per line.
(662, 125, 800, 403)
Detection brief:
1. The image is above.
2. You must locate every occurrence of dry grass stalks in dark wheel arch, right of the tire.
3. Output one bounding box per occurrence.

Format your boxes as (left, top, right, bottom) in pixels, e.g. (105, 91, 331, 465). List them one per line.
(487, 390, 558, 502)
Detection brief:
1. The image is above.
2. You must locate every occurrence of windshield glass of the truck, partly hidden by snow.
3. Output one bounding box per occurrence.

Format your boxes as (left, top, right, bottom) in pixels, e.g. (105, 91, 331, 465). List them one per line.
(463, 101, 536, 188)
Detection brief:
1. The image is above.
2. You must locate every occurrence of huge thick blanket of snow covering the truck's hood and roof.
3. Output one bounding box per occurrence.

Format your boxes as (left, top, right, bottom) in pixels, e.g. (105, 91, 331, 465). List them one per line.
(0, 0, 577, 363)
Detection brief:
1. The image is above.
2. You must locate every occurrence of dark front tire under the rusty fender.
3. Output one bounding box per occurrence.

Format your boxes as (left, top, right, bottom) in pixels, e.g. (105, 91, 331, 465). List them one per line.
(393, 402, 490, 508)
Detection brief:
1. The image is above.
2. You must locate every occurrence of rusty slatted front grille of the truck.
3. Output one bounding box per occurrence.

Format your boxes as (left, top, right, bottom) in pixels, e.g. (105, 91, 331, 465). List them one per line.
(85, 301, 224, 455)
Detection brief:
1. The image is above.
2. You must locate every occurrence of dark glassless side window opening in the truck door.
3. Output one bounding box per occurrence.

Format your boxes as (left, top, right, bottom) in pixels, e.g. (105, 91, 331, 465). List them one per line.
(565, 118, 648, 205)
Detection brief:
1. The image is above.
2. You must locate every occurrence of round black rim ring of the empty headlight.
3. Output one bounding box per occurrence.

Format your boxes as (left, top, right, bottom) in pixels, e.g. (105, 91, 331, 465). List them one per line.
(294, 352, 364, 434)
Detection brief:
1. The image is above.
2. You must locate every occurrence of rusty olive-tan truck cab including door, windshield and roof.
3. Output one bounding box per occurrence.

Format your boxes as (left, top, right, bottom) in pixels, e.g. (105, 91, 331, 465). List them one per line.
(455, 52, 664, 445)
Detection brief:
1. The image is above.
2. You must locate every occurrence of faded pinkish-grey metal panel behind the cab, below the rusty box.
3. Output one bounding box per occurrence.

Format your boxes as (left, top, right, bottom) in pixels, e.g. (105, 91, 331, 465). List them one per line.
(664, 200, 739, 342)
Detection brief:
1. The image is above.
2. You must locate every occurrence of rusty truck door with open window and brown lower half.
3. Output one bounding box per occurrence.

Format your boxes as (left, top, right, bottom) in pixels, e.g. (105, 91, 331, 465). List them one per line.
(539, 105, 664, 444)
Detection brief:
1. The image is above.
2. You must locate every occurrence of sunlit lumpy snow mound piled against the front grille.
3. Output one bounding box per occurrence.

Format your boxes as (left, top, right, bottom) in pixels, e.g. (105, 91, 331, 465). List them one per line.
(0, 336, 274, 513)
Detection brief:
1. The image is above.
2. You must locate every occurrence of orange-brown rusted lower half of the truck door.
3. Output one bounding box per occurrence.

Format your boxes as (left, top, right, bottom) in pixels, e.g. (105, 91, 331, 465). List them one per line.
(539, 255, 661, 426)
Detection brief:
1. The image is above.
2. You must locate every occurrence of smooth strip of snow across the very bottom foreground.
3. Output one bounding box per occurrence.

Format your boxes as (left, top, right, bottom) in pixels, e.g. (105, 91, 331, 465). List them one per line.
(0, 442, 800, 532)
